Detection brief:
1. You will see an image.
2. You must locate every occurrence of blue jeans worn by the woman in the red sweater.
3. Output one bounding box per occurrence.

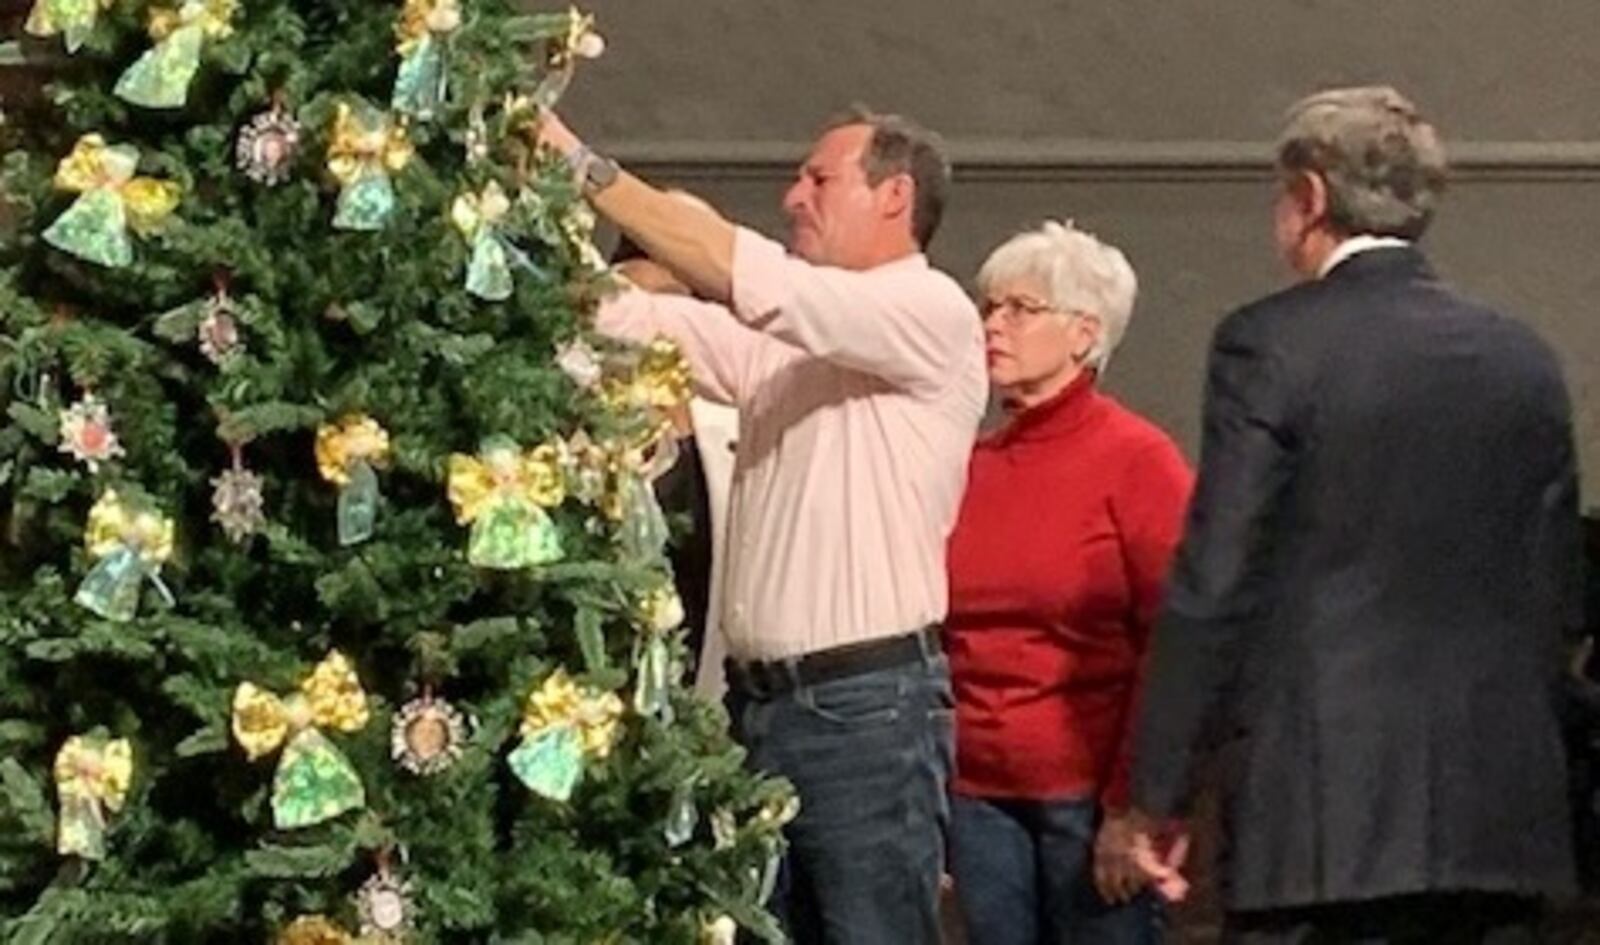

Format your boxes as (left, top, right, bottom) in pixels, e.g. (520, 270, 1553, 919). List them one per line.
(950, 795, 1162, 945)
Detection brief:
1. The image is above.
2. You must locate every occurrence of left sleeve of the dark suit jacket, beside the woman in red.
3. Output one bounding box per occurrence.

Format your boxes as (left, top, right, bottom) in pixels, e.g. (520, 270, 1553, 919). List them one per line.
(1131, 310, 1294, 817)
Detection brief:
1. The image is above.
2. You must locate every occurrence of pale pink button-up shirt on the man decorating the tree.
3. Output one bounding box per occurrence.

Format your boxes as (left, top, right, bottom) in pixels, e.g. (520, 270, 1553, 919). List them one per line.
(595, 229, 987, 660)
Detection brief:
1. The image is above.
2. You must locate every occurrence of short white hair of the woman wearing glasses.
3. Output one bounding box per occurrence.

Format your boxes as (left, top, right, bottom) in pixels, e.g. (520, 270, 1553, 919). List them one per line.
(978, 221, 1139, 374)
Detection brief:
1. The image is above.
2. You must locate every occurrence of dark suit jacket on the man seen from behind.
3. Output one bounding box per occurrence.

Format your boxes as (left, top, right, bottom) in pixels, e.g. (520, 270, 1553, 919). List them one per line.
(1133, 248, 1581, 910)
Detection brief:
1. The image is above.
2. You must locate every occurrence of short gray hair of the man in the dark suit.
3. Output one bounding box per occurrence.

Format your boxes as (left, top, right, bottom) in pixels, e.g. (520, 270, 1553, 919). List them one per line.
(1278, 86, 1448, 240)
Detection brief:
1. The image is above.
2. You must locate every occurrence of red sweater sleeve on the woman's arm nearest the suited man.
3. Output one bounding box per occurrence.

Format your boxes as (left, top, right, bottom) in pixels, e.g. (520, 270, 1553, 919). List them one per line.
(1101, 438, 1194, 811)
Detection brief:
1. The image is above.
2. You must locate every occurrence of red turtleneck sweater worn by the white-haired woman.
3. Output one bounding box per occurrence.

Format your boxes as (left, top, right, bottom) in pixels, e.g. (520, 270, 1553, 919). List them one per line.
(946, 374, 1194, 807)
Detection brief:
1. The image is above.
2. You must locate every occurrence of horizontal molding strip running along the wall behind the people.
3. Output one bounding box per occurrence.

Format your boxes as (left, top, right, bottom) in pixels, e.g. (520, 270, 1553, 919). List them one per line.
(603, 139, 1600, 182)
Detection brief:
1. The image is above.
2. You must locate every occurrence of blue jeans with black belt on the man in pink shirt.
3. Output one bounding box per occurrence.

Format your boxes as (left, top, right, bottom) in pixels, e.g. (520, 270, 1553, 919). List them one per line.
(728, 652, 955, 945)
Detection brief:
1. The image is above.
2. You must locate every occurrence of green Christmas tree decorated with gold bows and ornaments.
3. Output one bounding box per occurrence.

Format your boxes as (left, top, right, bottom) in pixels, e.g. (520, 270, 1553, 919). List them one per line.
(0, 0, 794, 943)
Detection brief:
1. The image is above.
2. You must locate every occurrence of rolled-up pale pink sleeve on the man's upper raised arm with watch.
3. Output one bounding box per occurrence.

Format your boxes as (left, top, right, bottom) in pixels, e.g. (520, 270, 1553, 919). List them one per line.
(733, 229, 981, 393)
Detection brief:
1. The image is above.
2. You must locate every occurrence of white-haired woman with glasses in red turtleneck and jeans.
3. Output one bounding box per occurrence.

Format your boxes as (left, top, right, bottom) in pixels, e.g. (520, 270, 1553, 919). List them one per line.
(946, 222, 1192, 945)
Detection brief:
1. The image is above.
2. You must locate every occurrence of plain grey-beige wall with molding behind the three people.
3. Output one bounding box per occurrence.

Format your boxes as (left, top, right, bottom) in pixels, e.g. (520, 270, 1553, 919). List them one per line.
(566, 0, 1600, 502)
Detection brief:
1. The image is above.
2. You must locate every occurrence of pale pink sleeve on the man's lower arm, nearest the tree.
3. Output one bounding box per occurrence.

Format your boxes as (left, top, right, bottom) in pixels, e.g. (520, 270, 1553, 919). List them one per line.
(595, 286, 771, 405)
